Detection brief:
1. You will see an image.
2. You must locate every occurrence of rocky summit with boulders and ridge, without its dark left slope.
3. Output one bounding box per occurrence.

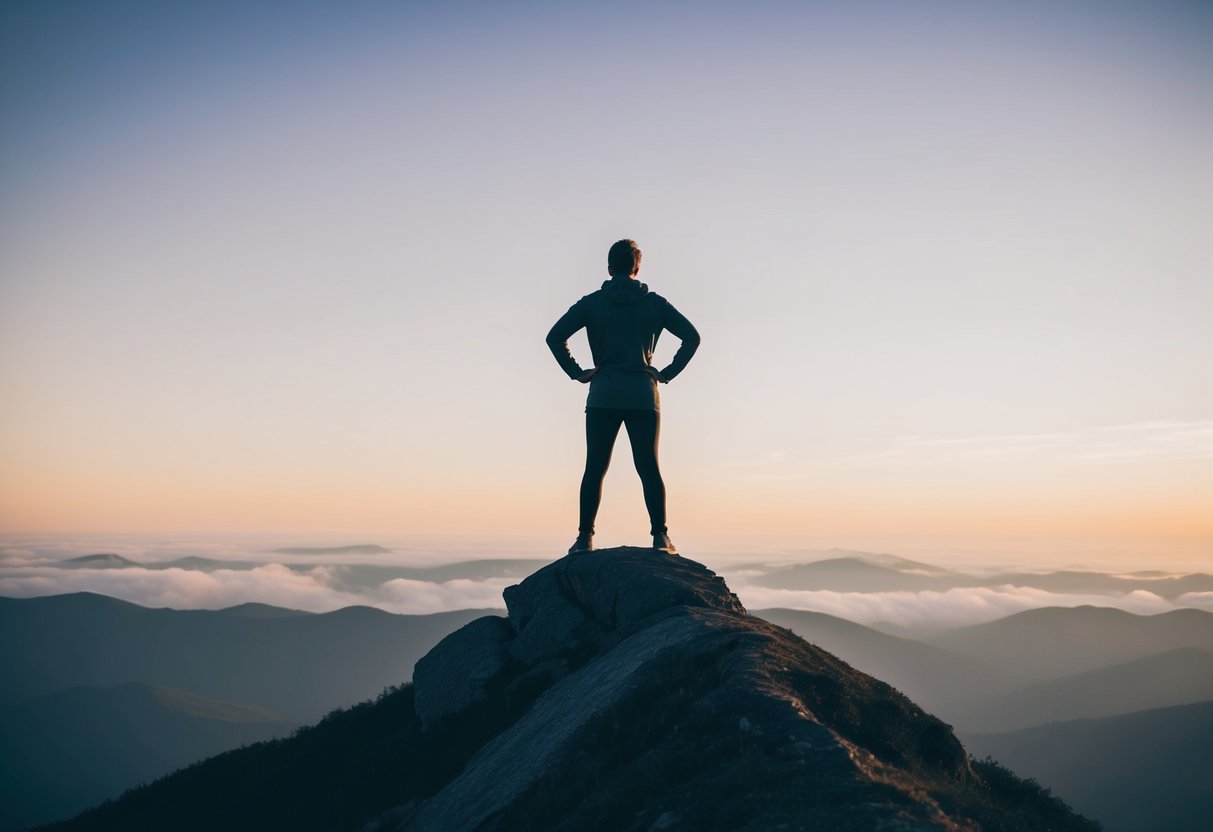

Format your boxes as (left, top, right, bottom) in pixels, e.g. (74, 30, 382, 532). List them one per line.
(364, 547, 1098, 832)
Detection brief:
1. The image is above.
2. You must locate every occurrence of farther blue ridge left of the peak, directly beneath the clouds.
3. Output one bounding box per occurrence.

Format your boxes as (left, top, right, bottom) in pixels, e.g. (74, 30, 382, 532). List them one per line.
(0, 593, 492, 722)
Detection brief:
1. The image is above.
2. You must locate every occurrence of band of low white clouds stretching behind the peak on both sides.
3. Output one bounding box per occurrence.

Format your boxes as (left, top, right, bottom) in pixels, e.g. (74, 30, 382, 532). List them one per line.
(0, 540, 1213, 628)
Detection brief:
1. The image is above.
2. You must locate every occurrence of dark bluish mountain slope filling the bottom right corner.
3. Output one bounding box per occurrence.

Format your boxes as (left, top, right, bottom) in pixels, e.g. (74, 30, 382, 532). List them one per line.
(964, 702, 1213, 832)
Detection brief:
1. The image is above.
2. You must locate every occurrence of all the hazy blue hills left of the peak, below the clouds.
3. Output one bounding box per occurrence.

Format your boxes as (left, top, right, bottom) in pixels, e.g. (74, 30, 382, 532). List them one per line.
(0, 593, 492, 830)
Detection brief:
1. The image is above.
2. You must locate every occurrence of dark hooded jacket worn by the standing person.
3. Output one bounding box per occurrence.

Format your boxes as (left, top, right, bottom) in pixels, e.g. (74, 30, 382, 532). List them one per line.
(547, 275, 699, 410)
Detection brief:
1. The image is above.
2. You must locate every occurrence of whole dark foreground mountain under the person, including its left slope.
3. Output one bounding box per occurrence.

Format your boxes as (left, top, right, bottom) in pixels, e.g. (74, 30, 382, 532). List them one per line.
(42, 548, 1094, 832)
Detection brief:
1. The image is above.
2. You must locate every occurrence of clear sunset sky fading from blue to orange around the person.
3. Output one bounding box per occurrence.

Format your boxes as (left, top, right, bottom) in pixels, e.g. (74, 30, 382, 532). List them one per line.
(0, 0, 1213, 569)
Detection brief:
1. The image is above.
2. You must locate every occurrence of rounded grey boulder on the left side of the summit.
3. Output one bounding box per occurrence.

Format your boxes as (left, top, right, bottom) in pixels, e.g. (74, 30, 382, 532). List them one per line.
(412, 615, 513, 729)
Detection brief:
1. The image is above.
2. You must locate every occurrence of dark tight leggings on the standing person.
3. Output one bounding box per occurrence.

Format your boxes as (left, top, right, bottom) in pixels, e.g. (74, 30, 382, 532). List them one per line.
(580, 408, 666, 535)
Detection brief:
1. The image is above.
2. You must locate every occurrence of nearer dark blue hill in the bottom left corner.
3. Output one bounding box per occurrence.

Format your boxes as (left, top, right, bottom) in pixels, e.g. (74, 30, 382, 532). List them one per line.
(0, 683, 295, 828)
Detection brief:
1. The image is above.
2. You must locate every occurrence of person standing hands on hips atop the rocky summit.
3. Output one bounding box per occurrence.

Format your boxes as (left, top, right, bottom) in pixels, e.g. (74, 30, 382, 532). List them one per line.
(547, 240, 699, 554)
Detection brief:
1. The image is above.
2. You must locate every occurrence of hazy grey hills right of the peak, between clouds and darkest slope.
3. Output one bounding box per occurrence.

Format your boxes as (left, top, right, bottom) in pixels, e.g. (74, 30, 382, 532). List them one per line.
(754, 606, 1213, 731)
